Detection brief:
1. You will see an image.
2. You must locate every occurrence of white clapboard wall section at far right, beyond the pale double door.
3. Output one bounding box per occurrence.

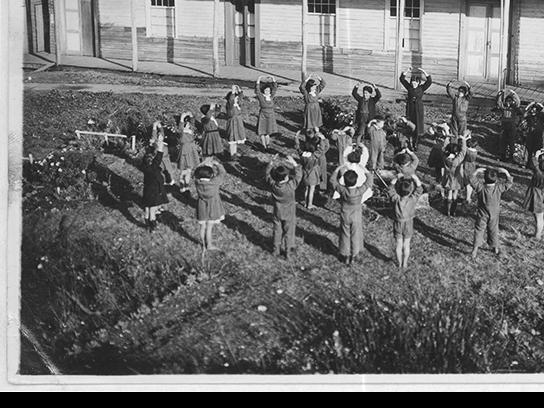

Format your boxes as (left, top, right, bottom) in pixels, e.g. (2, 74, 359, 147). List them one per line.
(518, 0, 544, 84)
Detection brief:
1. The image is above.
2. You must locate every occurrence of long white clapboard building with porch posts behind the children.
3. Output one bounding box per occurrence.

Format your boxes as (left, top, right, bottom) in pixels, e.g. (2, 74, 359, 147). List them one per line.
(25, 0, 544, 86)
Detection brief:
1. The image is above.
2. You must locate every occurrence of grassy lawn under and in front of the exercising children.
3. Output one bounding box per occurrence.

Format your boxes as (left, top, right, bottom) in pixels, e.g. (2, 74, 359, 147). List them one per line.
(22, 92, 544, 374)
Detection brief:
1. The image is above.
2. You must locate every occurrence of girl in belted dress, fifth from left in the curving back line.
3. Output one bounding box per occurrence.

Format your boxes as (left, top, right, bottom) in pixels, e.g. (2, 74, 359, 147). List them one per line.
(255, 76, 278, 151)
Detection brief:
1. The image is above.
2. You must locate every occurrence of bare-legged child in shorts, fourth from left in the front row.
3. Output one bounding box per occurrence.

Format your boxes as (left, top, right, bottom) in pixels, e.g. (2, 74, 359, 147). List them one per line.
(389, 174, 423, 270)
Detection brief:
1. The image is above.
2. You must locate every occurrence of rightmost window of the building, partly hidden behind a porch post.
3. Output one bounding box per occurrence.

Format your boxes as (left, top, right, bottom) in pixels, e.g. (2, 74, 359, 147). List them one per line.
(388, 0, 424, 52)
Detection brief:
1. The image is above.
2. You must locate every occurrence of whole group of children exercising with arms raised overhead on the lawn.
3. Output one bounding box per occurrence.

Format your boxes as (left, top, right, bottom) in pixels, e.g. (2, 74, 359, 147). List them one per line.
(144, 70, 544, 269)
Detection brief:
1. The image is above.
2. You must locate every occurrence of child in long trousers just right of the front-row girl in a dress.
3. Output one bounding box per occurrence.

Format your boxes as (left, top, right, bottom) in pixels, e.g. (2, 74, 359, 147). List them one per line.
(266, 156, 302, 261)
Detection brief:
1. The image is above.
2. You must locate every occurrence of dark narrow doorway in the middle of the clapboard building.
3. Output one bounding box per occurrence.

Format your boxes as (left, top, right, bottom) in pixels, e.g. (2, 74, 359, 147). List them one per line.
(233, 0, 257, 66)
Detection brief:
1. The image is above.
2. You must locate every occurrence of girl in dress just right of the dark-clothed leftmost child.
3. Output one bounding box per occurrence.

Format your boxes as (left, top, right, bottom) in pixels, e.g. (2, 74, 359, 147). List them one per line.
(178, 112, 200, 193)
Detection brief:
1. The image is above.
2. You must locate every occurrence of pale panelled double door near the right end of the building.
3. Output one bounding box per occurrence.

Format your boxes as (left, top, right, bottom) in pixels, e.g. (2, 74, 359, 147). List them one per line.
(466, 3, 501, 80)
